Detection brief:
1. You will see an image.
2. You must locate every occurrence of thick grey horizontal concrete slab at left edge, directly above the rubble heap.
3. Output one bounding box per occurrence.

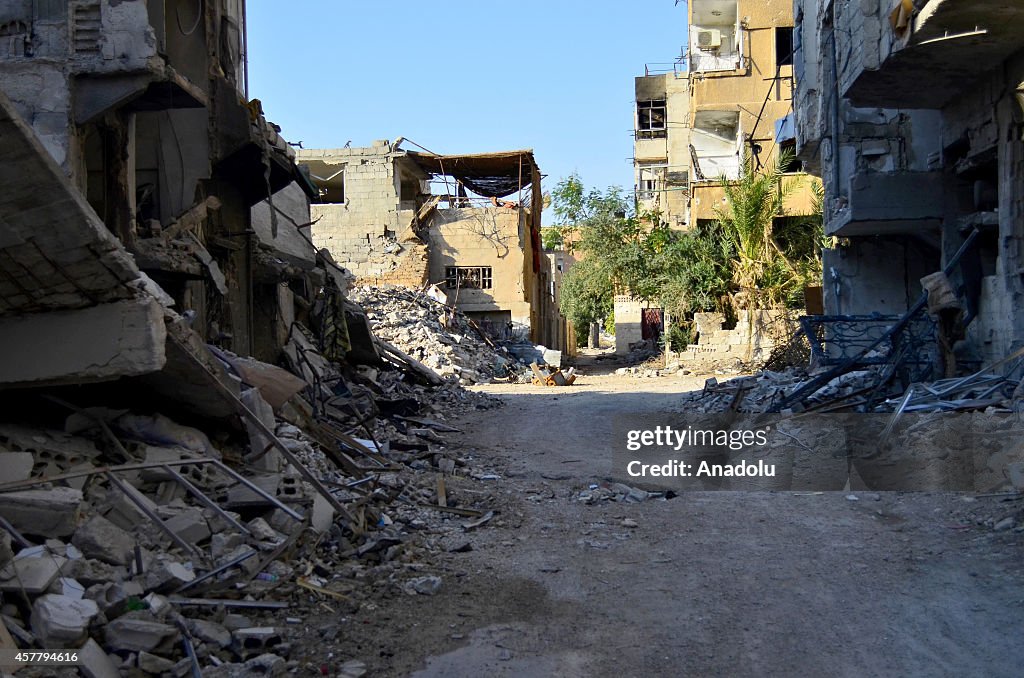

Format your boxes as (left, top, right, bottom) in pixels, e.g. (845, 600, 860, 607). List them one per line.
(0, 299, 166, 386)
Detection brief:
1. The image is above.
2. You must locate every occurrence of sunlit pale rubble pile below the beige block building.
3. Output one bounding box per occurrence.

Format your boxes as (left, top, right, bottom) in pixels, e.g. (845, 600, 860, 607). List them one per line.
(349, 287, 521, 385)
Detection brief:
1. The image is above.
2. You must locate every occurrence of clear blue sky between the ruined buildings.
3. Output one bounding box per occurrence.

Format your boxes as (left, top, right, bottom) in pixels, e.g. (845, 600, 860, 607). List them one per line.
(248, 0, 686, 215)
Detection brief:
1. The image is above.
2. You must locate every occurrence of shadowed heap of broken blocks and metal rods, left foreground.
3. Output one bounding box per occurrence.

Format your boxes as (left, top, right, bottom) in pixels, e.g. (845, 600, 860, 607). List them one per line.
(0, 340, 497, 678)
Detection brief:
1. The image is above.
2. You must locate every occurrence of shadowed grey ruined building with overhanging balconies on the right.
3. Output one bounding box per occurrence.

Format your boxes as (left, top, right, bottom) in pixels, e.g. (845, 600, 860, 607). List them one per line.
(795, 0, 1024, 370)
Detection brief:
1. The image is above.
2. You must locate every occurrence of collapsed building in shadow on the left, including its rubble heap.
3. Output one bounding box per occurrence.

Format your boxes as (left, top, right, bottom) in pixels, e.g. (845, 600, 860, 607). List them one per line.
(0, 0, 516, 677)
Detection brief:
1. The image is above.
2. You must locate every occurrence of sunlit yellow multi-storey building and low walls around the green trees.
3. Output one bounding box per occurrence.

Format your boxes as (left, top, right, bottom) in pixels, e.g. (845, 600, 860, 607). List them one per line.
(614, 0, 815, 364)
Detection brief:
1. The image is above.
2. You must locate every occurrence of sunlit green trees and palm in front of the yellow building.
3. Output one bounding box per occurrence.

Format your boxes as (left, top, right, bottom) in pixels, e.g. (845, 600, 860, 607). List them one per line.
(551, 154, 824, 337)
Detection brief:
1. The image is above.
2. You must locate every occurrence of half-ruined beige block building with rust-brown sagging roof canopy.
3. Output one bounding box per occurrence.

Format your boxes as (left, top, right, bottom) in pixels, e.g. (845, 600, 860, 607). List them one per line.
(298, 143, 574, 350)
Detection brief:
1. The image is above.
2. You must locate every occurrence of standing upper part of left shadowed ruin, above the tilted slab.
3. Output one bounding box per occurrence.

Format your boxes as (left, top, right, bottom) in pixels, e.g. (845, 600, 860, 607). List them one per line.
(0, 0, 315, 361)
